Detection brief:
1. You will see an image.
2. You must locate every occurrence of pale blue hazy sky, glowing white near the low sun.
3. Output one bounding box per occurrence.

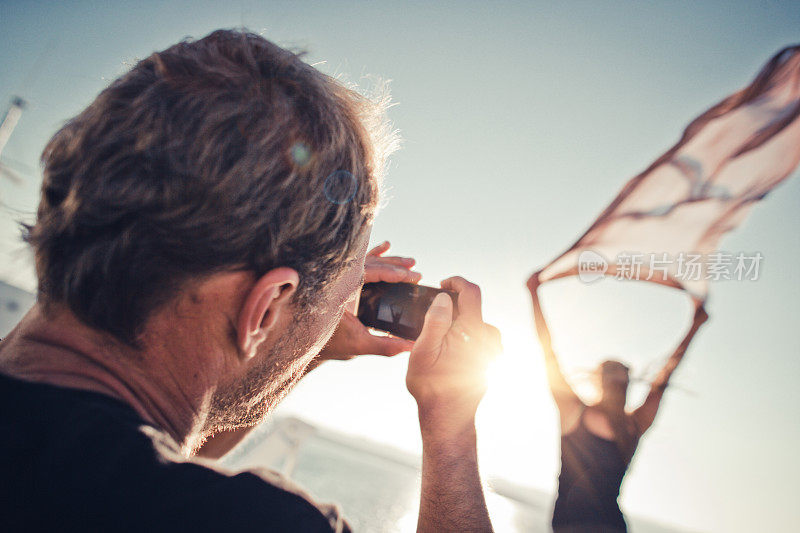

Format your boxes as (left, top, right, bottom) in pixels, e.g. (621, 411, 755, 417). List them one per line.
(0, 1, 800, 532)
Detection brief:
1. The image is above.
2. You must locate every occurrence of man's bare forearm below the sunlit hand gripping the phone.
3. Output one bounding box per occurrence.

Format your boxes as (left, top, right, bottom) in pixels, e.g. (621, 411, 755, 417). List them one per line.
(417, 413, 492, 533)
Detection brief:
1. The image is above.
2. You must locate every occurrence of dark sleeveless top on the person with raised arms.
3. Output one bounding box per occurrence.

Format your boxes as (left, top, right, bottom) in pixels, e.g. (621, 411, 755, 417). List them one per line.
(553, 411, 629, 533)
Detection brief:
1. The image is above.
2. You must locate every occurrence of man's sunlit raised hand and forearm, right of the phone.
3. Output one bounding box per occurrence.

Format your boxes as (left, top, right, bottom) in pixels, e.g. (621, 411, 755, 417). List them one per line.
(406, 277, 500, 533)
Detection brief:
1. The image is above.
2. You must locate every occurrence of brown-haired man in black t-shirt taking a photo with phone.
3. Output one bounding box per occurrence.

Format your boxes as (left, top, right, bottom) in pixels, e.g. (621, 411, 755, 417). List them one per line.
(0, 31, 499, 531)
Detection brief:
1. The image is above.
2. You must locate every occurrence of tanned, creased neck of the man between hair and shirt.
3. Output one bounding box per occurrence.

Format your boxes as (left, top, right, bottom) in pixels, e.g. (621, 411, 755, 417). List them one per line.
(0, 304, 215, 455)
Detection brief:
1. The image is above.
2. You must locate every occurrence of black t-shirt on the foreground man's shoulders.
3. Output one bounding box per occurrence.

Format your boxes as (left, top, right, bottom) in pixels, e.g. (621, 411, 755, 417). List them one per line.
(0, 375, 349, 532)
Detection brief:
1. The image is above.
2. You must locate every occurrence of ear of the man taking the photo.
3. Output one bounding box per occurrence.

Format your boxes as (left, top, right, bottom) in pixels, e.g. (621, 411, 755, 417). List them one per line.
(236, 267, 300, 360)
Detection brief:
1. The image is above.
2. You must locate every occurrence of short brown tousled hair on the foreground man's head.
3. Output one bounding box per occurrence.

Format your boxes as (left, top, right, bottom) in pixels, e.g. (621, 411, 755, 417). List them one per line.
(25, 30, 396, 345)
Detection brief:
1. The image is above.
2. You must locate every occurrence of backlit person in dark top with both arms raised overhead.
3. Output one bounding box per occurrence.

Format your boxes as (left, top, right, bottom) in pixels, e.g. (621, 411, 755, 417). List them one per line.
(528, 274, 708, 533)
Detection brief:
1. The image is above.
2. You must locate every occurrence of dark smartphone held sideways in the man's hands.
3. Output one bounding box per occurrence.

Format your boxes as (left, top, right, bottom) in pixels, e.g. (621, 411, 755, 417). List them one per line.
(358, 281, 458, 341)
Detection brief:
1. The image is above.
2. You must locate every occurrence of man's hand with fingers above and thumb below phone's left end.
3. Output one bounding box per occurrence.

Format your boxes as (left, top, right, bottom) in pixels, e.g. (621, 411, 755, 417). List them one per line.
(315, 241, 422, 364)
